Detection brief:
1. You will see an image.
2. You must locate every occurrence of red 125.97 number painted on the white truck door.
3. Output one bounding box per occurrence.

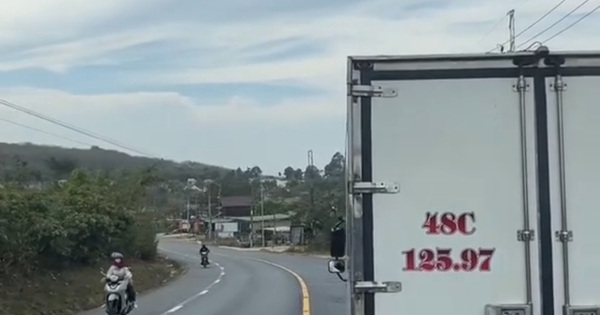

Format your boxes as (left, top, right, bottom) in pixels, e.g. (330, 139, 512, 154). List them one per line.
(402, 248, 495, 272)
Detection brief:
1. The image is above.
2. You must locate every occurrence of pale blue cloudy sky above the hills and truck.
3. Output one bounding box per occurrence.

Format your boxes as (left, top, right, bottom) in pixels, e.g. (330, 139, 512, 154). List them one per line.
(0, 0, 600, 174)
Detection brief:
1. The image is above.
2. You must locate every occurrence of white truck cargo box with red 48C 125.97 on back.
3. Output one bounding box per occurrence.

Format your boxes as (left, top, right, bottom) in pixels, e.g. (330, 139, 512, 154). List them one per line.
(346, 47, 600, 315)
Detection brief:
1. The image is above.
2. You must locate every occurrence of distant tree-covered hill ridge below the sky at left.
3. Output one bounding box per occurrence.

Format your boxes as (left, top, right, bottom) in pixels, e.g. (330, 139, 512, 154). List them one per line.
(0, 143, 228, 181)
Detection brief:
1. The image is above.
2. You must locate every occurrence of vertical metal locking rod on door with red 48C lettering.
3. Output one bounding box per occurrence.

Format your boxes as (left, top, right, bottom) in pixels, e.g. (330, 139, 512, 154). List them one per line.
(517, 71, 533, 305)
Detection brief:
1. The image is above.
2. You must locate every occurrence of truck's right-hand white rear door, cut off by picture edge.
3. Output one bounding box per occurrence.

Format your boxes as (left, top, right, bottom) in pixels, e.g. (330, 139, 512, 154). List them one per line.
(542, 54, 600, 315)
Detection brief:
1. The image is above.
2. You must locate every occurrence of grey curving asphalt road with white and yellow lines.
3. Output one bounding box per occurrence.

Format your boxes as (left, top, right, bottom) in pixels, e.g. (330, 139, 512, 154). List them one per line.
(82, 239, 349, 315)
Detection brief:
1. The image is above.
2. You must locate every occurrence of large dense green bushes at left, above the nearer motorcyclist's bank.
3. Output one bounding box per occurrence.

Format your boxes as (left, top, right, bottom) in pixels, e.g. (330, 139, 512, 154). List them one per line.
(0, 171, 157, 272)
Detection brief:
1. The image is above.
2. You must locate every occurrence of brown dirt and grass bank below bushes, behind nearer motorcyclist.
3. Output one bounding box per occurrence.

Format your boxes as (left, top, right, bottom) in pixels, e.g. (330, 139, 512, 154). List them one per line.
(0, 258, 183, 315)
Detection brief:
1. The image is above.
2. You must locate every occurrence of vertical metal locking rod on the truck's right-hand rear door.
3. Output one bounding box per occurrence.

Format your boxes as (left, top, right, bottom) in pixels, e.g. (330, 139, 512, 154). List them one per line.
(554, 65, 572, 307)
